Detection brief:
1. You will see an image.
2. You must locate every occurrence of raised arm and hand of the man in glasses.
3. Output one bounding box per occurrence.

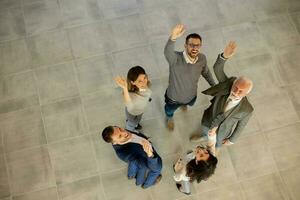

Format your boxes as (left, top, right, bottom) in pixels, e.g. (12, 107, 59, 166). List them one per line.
(164, 24, 185, 65)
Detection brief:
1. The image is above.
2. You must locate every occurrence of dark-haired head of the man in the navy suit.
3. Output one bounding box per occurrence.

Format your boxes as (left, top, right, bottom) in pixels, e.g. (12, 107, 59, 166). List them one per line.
(102, 126, 131, 144)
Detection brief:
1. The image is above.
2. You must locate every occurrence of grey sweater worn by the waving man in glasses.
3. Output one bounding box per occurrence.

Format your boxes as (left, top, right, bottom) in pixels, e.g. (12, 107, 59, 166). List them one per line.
(164, 39, 215, 104)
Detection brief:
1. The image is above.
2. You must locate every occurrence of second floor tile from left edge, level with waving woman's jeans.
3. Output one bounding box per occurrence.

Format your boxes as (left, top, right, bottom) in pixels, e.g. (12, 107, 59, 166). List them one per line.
(42, 98, 88, 143)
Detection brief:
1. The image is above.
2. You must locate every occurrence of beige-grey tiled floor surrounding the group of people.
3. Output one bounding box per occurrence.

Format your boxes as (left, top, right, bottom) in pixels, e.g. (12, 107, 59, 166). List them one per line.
(0, 0, 300, 200)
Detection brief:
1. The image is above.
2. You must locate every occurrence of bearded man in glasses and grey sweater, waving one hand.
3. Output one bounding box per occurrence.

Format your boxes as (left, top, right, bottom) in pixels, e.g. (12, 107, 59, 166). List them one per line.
(164, 24, 215, 130)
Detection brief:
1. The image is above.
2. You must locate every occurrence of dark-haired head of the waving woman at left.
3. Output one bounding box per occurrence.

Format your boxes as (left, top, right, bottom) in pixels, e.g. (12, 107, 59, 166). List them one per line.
(127, 66, 149, 92)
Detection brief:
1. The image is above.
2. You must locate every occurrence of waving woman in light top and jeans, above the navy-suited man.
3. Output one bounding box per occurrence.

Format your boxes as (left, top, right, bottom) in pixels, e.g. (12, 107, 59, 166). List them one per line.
(115, 66, 152, 132)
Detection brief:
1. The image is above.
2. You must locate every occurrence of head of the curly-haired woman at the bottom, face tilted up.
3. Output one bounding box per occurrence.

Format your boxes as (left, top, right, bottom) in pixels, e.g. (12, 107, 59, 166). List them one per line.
(186, 146, 218, 183)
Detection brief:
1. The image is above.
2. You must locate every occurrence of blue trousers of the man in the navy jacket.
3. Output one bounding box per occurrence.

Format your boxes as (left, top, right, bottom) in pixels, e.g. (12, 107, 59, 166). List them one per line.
(128, 156, 162, 188)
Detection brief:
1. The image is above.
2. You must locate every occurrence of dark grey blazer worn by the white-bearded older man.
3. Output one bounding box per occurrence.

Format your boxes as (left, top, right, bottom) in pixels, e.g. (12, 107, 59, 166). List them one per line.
(202, 55, 253, 146)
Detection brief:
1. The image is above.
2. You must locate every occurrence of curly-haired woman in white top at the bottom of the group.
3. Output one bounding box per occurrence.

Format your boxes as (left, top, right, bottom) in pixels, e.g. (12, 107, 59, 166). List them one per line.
(173, 128, 218, 195)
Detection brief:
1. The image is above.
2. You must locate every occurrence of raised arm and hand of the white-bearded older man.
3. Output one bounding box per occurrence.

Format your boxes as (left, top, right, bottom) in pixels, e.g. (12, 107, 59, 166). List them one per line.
(214, 41, 237, 82)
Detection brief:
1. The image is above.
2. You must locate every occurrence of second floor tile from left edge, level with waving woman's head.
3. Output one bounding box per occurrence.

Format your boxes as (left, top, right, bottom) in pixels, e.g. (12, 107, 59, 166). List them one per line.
(35, 63, 79, 104)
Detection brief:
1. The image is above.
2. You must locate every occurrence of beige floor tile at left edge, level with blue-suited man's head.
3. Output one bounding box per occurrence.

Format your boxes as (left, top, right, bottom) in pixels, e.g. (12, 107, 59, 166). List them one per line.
(0, 107, 47, 153)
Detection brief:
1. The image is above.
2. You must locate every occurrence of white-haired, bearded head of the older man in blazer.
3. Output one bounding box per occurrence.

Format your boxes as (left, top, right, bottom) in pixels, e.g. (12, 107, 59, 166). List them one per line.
(229, 76, 253, 100)
